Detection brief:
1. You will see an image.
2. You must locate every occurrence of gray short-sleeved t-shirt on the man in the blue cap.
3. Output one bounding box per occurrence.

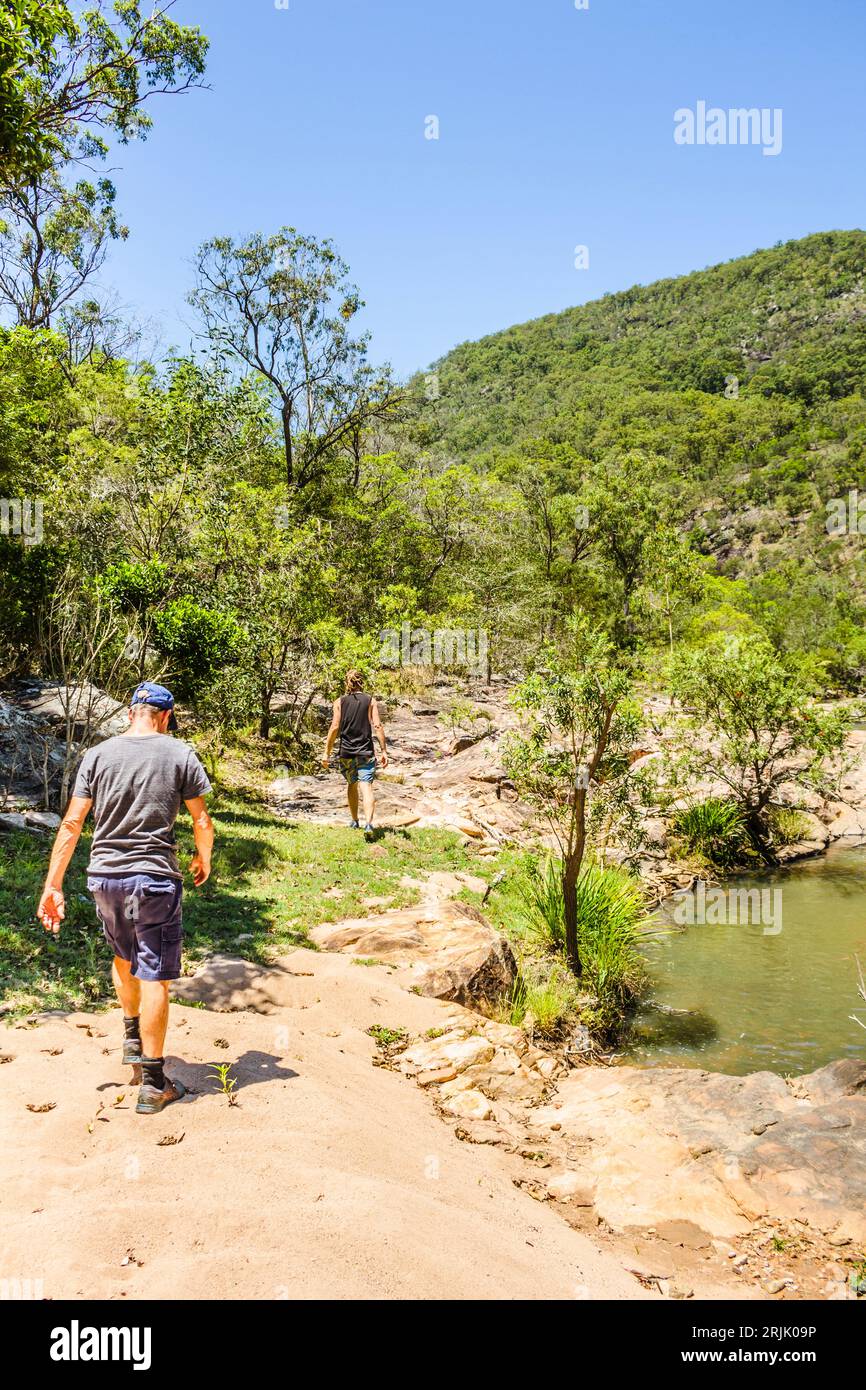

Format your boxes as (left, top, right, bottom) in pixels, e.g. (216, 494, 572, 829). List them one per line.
(72, 734, 211, 878)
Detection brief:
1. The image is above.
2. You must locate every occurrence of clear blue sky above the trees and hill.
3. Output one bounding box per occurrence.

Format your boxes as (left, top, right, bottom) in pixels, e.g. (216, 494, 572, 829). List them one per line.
(101, 0, 866, 375)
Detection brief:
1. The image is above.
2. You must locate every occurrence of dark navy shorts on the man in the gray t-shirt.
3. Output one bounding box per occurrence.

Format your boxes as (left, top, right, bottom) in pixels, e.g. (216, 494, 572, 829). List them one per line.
(88, 873, 183, 980)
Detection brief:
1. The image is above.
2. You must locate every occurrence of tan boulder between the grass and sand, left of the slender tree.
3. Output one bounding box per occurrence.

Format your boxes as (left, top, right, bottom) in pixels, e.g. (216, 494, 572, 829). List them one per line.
(310, 899, 516, 1004)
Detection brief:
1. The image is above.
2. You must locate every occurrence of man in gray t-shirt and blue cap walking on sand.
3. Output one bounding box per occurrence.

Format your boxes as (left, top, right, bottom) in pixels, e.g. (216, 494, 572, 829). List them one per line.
(38, 681, 214, 1115)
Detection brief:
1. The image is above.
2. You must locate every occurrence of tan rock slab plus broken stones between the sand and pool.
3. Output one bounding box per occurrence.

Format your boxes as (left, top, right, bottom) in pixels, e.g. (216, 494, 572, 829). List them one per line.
(396, 1015, 866, 1297)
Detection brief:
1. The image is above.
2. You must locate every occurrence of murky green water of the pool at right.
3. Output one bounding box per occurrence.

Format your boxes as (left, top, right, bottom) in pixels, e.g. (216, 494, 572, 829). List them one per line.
(623, 848, 866, 1076)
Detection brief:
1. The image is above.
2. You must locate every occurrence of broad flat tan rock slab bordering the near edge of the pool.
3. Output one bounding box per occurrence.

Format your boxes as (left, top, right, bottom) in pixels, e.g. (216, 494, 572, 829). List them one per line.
(535, 1059, 866, 1245)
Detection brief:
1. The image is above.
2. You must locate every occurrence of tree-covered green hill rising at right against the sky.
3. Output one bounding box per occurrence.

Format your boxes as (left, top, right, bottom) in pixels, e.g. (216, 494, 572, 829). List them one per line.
(400, 231, 866, 685)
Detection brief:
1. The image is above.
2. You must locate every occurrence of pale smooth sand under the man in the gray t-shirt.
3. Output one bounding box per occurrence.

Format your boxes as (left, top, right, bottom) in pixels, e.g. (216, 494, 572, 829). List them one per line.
(0, 951, 664, 1300)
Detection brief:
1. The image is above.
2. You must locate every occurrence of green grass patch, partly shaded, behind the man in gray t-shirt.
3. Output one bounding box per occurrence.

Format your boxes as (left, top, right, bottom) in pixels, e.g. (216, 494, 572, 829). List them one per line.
(0, 794, 489, 1016)
